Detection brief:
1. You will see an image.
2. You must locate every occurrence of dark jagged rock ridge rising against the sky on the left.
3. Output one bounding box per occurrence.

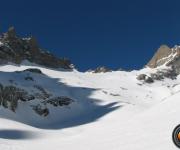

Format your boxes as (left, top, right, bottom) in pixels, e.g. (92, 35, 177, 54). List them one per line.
(0, 27, 72, 69)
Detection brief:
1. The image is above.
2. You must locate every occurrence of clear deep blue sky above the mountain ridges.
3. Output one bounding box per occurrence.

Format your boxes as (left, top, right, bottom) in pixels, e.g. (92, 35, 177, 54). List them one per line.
(0, 0, 180, 70)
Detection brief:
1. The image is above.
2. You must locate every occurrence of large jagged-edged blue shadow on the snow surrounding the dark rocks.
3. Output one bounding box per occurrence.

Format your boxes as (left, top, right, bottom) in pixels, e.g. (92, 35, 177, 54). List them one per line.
(0, 72, 123, 129)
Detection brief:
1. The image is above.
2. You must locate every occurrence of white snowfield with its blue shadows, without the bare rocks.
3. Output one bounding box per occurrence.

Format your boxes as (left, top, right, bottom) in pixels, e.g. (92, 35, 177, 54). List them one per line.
(0, 65, 180, 150)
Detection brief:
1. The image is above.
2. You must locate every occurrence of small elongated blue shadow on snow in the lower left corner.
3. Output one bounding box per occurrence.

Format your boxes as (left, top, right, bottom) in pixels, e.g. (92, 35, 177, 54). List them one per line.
(0, 129, 39, 140)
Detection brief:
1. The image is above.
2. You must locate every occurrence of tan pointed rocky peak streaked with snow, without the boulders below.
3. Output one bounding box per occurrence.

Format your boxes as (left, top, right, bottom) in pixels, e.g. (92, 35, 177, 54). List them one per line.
(147, 45, 180, 74)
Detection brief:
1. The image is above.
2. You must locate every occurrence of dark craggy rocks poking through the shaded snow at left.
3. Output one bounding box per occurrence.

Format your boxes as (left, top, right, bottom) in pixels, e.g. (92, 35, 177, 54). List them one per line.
(0, 83, 74, 117)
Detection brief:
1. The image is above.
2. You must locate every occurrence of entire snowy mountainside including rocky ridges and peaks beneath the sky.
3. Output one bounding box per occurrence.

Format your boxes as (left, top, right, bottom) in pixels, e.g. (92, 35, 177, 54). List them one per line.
(0, 28, 180, 150)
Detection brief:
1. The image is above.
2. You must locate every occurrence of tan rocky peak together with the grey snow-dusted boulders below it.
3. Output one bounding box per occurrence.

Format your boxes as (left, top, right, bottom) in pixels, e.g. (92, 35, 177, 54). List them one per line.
(137, 45, 180, 83)
